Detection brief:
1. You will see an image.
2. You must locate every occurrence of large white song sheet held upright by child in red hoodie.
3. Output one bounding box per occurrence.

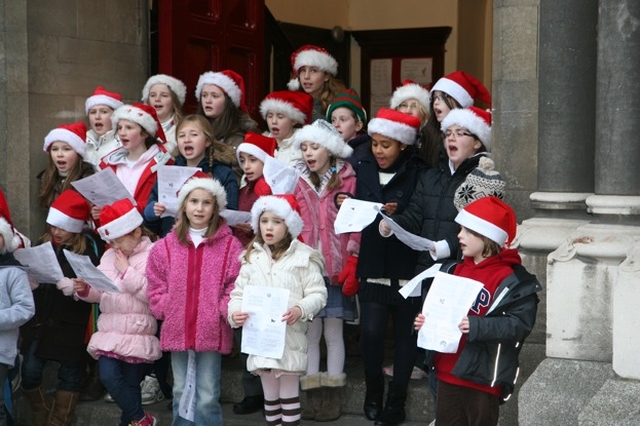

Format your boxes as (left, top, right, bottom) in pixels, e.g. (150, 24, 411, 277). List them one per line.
(418, 272, 483, 353)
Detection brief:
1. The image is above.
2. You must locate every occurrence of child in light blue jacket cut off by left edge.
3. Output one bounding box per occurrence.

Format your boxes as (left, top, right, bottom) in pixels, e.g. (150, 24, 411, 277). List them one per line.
(0, 200, 35, 426)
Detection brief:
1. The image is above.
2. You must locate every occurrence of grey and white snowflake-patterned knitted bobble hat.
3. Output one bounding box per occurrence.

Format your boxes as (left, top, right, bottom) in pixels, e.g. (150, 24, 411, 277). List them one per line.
(453, 157, 507, 211)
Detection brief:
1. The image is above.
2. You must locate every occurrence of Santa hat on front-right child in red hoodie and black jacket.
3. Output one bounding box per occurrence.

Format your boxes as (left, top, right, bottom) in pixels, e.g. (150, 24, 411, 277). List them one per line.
(456, 197, 518, 247)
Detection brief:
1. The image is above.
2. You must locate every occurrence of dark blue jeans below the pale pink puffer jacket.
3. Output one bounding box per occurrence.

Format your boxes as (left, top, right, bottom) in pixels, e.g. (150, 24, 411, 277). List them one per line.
(98, 356, 148, 426)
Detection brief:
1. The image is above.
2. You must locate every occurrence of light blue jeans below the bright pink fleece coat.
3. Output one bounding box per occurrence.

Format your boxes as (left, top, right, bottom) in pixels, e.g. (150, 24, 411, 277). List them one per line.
(171, 351, 222, 426)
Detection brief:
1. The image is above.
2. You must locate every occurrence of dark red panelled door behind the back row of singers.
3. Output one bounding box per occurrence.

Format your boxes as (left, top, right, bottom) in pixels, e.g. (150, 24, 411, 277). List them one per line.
(158, 0, 265, 118)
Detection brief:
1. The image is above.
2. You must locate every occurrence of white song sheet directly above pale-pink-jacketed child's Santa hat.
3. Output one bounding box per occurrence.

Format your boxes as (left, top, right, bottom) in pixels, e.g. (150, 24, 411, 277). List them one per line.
(71, 167, 136, 208)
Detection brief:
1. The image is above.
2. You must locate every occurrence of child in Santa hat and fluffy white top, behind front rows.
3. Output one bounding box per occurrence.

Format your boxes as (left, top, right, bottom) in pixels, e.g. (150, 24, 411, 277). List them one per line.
(260, 90, 313, 166)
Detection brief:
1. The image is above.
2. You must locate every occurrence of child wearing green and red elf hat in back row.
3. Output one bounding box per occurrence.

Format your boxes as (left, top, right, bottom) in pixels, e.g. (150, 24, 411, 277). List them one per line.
(327, 89, 371, 171)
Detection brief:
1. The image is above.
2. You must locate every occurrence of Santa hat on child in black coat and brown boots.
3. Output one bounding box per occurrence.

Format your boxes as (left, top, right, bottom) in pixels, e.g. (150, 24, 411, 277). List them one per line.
(47, 189, 91, 234)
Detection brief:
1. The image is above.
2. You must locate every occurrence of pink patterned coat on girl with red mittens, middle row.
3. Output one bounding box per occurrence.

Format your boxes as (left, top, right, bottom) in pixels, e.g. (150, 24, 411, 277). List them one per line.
(295, 160, 359, 284)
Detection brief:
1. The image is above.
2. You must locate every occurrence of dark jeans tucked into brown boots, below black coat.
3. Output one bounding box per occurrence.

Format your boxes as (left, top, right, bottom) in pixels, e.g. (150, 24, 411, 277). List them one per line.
(22, 340, 84, 392)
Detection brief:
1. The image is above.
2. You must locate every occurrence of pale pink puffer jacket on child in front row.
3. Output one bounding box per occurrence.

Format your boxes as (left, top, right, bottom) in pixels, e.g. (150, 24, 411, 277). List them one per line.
(78, 237, 162, 362)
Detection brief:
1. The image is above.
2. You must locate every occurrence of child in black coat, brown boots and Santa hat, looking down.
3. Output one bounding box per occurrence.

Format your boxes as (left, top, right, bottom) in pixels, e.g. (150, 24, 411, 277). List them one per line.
(21, 190, 101, 426)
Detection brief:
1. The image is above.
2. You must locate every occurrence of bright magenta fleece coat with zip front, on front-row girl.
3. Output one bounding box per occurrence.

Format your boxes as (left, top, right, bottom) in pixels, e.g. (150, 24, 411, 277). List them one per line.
(147, 224, 242, 354)
